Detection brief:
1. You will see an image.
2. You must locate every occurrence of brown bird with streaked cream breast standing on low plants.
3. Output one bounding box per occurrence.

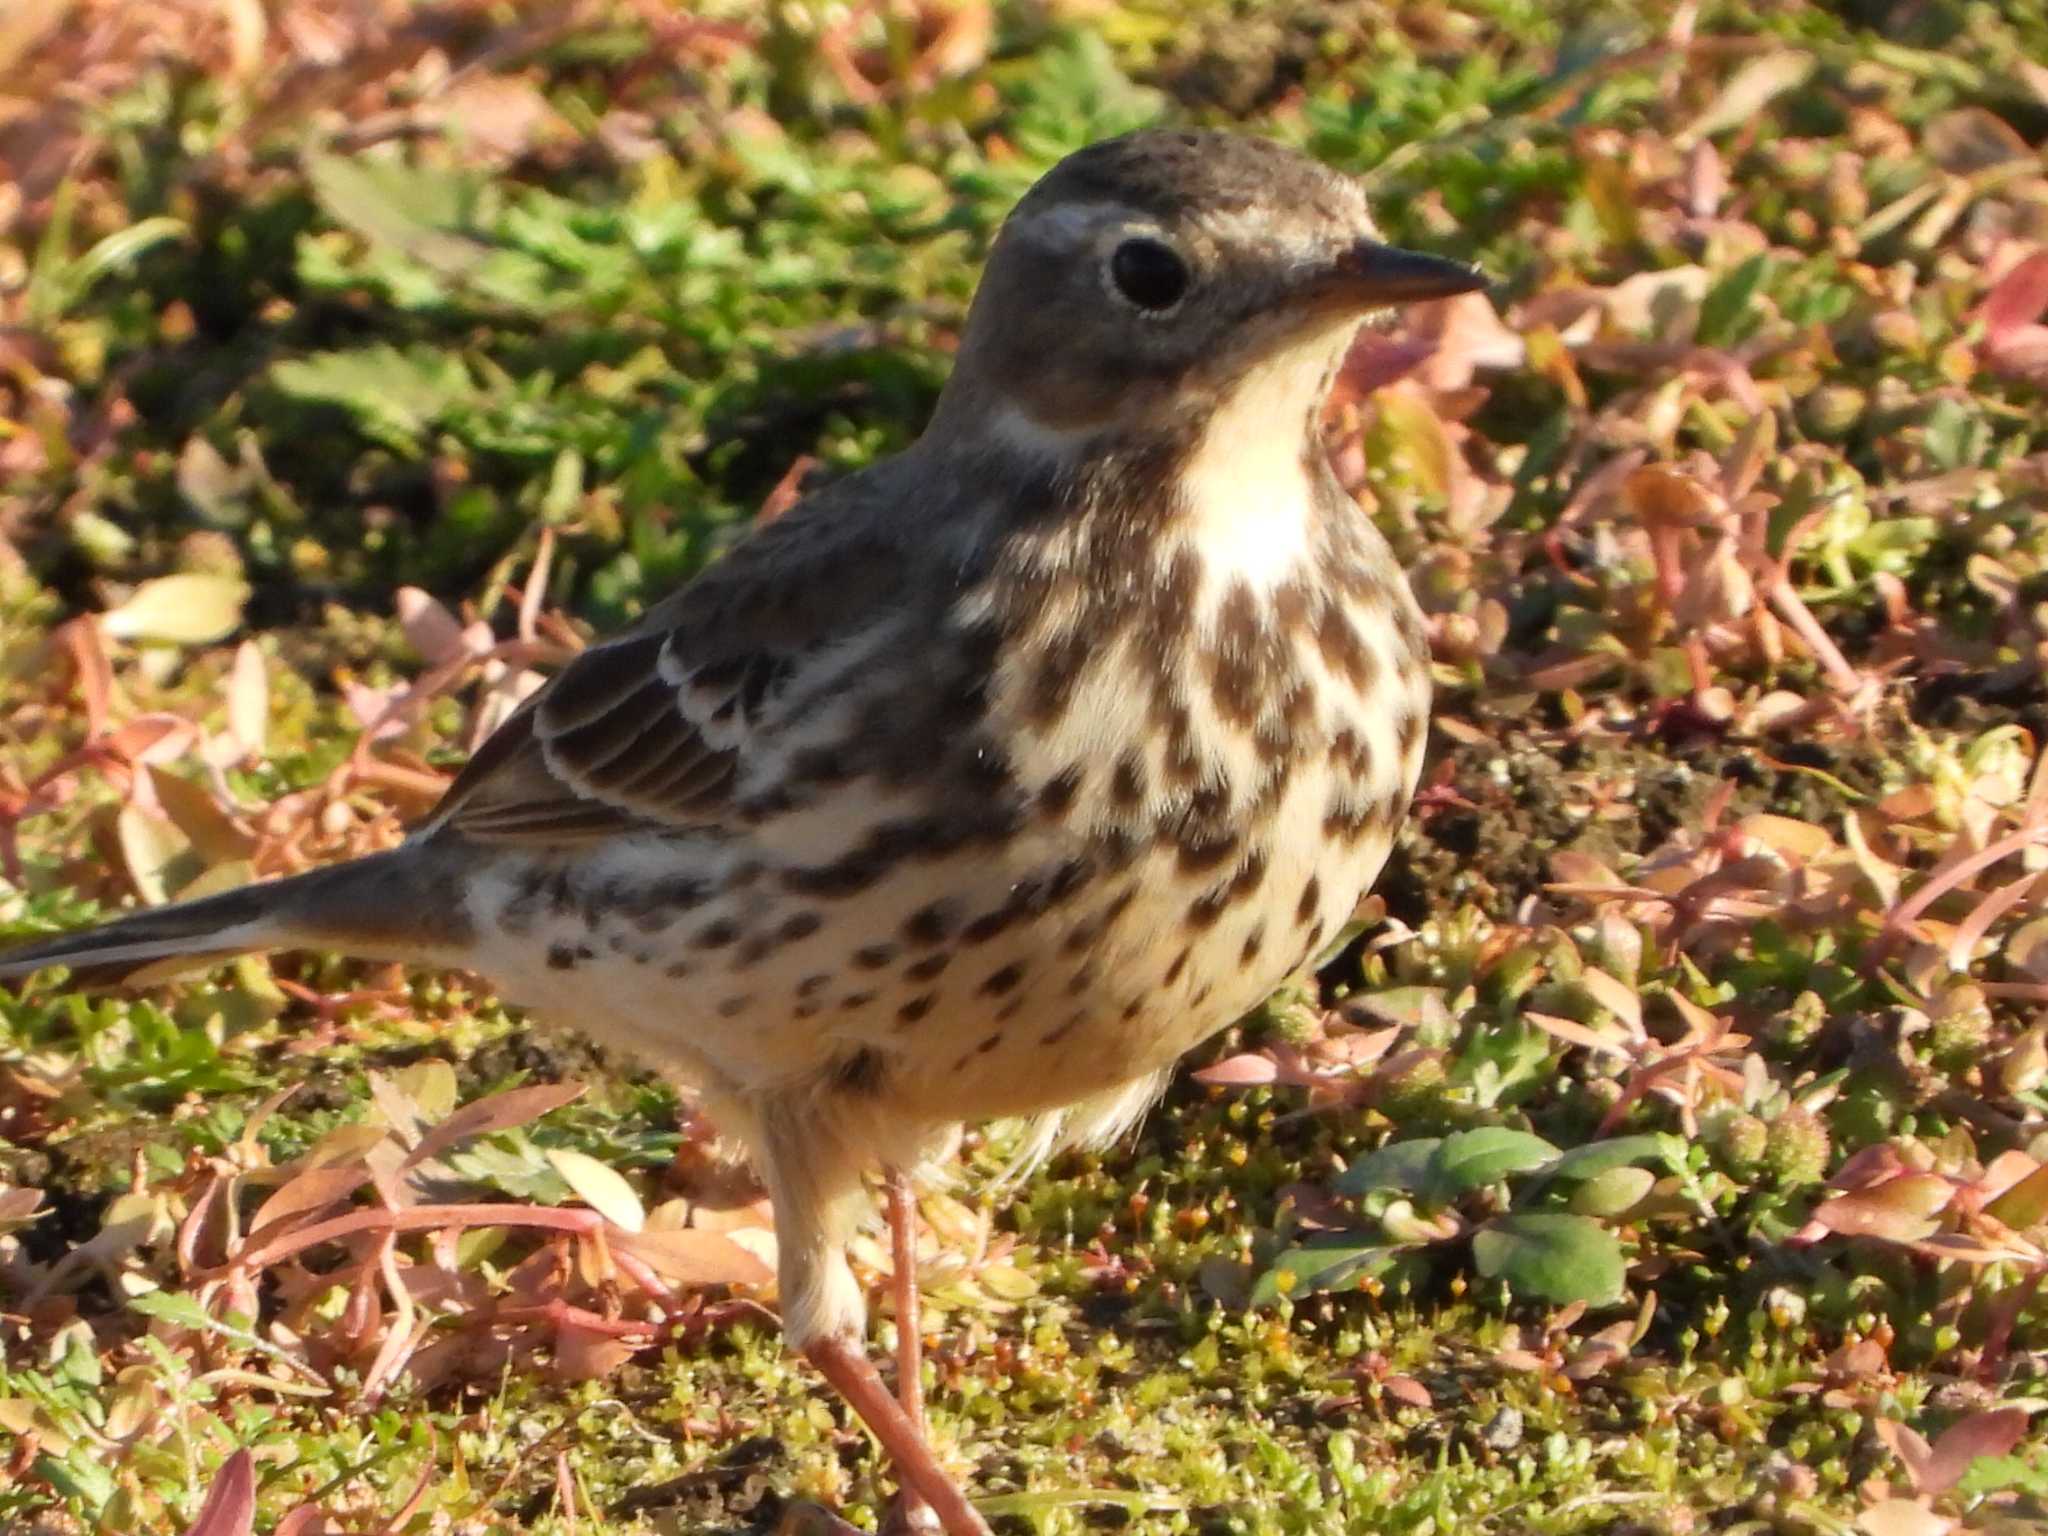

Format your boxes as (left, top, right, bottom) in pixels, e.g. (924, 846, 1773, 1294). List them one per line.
(0, 129, 1485, 1536)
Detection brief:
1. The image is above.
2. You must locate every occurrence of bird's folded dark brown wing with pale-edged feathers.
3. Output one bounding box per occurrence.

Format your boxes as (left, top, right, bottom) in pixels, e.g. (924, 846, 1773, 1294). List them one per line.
(428, 471, 909, 844)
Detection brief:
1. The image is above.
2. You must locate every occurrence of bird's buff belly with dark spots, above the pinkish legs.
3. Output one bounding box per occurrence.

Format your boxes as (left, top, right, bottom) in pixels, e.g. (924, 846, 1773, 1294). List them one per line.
(456, 749, 1391, 1122)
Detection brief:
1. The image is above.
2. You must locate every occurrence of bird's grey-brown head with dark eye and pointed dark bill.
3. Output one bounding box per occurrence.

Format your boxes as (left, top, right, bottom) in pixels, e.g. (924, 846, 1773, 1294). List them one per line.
(940, 131, 1485, 453)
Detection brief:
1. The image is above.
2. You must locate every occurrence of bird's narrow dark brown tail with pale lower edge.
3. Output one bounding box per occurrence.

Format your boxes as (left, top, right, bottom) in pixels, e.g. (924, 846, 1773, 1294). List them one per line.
(0, 848, 456, 987)
